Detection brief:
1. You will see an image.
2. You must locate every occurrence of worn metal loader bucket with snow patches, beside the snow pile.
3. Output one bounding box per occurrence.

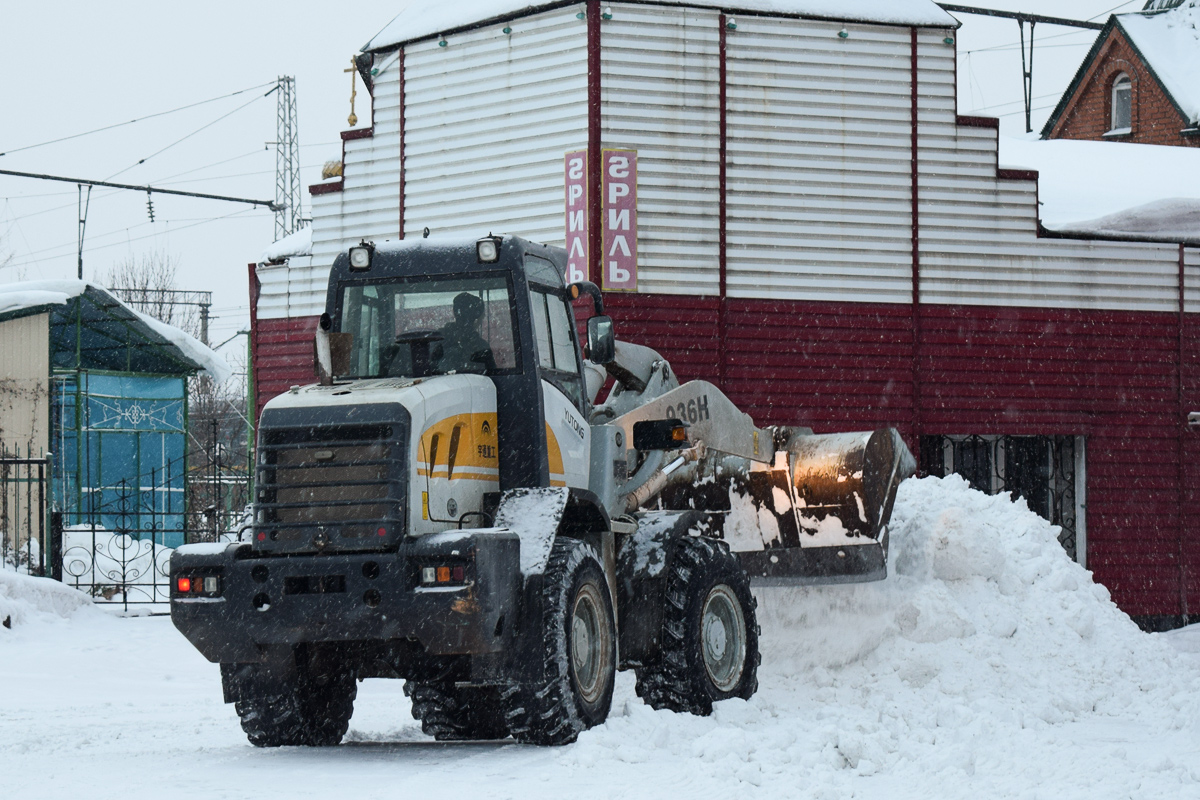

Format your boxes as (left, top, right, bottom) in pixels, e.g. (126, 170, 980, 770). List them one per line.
(724, 428, 917, 583)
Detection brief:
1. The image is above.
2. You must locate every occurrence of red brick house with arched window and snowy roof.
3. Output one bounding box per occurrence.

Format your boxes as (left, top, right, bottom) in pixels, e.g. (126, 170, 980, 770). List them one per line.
(1042, 0, 1200, 148)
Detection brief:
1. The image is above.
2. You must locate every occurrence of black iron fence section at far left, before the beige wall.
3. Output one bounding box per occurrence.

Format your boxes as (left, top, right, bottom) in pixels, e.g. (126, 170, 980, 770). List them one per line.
(0, 457, 53, 576)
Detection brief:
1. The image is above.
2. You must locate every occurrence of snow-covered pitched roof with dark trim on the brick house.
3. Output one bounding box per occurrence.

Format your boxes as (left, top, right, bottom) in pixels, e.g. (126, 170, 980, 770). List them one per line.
(1042, 0, 1200, 137)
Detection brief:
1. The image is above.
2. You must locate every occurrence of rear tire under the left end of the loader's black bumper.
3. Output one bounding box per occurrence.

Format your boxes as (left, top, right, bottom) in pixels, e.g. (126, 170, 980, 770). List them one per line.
(221, 664, 358, 747)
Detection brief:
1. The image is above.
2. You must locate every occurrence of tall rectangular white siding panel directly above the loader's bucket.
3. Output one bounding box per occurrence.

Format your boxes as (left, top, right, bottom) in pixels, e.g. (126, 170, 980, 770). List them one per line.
(726, 17, 912, 302)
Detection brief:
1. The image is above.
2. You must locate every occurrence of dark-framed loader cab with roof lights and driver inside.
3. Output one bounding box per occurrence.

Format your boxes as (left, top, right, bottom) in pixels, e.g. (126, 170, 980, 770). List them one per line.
(325, 236, 589, 489)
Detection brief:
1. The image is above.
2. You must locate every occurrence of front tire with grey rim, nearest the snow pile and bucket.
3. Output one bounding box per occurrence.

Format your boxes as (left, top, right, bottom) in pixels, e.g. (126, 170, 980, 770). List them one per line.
(637, 536, 760, 716)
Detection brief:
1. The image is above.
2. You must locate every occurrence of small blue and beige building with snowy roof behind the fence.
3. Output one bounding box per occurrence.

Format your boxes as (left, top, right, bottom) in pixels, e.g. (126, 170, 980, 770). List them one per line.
(0, 282, 223, 547)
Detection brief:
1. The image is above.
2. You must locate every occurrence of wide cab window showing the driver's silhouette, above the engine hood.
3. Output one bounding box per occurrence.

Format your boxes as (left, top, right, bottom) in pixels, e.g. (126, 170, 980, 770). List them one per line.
(341, 275, 517, 378)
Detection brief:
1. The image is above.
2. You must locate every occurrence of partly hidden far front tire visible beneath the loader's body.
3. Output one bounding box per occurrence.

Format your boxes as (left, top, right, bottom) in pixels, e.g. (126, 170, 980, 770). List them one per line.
(404, 681, 509, 741)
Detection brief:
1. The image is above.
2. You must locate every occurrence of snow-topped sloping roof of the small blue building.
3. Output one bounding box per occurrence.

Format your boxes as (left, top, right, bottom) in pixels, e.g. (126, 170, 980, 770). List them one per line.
(0, 281, 233, 383)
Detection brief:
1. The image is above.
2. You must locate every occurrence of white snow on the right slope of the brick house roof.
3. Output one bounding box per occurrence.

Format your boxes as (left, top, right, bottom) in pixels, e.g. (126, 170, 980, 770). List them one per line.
(1117, 0, 1200, 125)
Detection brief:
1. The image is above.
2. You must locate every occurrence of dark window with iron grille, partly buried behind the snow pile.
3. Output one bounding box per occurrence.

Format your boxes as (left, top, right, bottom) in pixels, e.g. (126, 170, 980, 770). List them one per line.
(920, 435, 1086, 564)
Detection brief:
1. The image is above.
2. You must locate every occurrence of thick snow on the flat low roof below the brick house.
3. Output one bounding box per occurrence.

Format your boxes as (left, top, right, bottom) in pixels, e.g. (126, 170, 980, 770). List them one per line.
(1000, 137, 1200, 243)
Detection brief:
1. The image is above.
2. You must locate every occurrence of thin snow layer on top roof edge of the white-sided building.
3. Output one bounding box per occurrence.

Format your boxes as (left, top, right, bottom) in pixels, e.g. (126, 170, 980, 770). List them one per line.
(362, 0, 959, 50)
